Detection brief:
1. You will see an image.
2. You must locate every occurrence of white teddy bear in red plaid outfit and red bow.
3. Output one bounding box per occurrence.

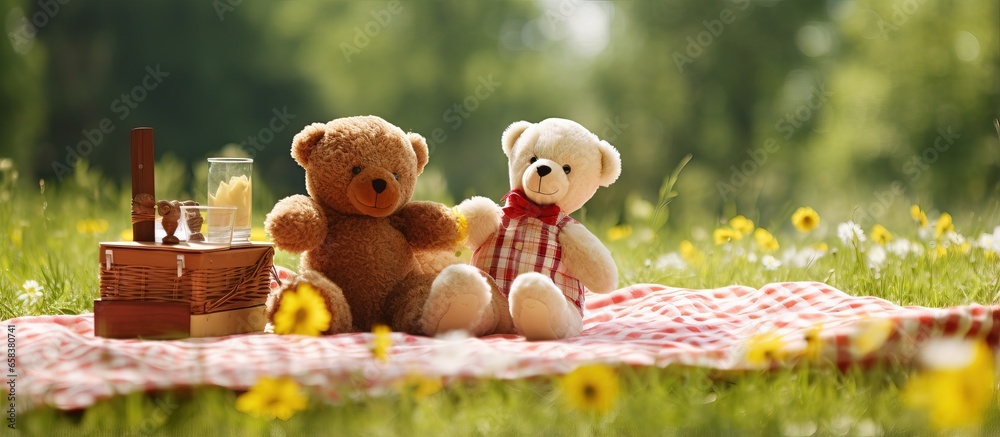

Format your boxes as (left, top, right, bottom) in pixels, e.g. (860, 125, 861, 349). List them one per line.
(458, 118, 621, 340)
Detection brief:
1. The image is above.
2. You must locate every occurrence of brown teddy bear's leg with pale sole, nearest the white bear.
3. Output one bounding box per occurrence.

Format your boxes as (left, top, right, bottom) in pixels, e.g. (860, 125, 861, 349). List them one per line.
(421, 264, 499, 336)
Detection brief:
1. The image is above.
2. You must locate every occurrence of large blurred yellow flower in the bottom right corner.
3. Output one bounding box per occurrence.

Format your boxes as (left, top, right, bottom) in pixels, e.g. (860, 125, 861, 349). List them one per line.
(902, 341, 996, 429)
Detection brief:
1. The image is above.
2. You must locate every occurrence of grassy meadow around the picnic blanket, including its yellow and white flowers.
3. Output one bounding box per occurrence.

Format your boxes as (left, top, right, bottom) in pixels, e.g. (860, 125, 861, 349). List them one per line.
(0, 160, 1000, 436)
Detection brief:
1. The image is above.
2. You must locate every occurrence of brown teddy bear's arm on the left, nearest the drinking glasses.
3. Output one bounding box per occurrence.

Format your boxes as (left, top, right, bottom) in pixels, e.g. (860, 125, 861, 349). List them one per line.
(264, 194, 327, 253)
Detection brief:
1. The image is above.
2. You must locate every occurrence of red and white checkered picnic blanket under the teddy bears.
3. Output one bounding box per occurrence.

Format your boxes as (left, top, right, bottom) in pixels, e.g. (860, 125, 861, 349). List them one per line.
(4, 283, 1000, 409)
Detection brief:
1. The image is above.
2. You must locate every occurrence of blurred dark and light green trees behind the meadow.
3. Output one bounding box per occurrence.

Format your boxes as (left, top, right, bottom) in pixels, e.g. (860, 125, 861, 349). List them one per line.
(0, 0, 1000, 232)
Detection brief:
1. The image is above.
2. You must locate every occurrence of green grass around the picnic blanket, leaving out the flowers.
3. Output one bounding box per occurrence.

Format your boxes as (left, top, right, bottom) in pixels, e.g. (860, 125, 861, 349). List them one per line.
(0, 158, 1000, 435)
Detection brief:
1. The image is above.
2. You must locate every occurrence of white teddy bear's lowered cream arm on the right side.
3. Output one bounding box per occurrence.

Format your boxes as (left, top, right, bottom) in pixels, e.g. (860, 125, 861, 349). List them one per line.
(559, 223, 618, 293)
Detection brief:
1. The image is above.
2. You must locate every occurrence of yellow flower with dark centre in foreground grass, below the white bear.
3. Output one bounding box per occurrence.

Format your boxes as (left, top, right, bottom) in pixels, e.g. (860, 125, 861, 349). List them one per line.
(559, 364, 619, 413)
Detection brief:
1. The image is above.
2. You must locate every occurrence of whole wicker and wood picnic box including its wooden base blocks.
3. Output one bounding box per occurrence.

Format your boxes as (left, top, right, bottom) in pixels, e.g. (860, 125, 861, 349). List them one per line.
(94, 242, 274, 338)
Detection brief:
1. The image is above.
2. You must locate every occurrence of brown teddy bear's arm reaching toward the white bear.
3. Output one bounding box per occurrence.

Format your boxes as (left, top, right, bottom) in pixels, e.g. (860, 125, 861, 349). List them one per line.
(392, 201, 459, 250)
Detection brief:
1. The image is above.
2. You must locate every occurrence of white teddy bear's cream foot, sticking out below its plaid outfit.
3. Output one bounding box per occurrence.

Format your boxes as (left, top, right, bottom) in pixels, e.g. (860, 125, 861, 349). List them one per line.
(510, 272, 583, 341)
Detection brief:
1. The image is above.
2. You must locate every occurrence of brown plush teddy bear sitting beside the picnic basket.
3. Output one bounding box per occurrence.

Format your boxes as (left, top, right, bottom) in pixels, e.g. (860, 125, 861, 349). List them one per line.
(265, 116, 512, 335)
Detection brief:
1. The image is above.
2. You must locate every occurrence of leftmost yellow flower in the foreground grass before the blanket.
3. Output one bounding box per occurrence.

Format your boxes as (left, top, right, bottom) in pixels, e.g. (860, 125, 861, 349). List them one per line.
(236, 376, 307, 420)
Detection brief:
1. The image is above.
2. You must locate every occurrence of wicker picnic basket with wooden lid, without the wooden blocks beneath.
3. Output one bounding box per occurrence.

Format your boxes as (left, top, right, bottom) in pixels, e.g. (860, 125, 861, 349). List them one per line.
(100, 241, 274, 315)
